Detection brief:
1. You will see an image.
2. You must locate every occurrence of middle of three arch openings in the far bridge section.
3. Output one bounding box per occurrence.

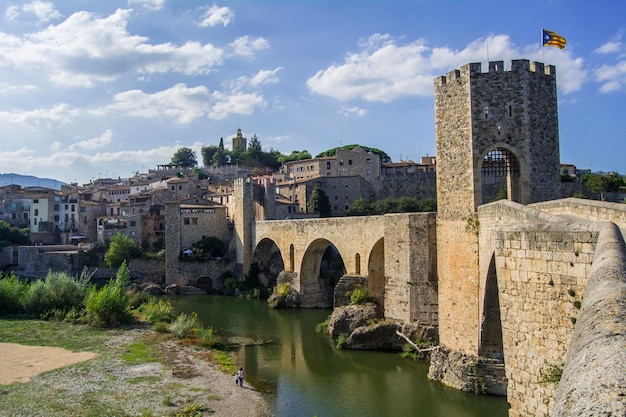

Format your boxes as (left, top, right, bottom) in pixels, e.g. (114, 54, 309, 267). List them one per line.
(299, 238, 346, 308)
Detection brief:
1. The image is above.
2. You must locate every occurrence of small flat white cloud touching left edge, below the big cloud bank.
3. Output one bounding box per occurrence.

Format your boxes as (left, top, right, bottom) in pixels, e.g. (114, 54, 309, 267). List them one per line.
(0, 104, 80, 130)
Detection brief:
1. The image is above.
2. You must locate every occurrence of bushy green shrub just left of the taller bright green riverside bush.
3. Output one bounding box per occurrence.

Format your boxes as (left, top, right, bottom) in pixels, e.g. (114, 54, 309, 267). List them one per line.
(24, 272, 89, 316)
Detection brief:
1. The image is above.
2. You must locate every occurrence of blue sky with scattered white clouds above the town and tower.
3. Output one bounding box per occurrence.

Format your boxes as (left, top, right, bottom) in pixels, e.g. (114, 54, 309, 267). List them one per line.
(0, 0, 626, 183)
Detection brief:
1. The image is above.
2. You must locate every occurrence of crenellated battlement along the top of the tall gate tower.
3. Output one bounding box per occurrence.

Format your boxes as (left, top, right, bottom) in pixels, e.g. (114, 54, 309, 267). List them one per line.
(435, 59, 556, 87)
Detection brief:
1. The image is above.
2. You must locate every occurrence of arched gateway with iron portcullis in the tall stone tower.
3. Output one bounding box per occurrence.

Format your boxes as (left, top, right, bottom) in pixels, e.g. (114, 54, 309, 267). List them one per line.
(476, 142, 527, 204)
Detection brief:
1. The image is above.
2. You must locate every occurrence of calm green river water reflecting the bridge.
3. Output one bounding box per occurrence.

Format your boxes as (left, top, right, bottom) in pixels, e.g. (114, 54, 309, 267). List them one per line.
(172, 295, 508, 417)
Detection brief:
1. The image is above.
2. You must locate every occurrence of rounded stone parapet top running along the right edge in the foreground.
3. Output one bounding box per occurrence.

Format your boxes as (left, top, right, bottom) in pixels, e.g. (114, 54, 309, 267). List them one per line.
(551, 223, 626, 417)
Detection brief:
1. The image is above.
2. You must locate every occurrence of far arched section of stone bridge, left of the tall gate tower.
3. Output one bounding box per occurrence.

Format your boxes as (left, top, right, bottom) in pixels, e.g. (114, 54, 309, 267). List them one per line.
(252, 213, 436, 321)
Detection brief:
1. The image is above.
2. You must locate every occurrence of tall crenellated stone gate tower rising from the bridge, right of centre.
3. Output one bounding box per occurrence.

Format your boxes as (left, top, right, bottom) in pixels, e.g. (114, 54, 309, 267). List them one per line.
(434, 60, 560, 355)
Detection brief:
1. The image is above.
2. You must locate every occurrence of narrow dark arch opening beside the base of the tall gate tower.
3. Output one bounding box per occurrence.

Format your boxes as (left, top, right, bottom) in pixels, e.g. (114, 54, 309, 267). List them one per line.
(478, 255, 504, 361)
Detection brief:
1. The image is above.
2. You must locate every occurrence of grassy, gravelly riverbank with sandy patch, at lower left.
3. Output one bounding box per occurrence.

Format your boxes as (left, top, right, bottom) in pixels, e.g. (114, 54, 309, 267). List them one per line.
(0, 320, 269, 417)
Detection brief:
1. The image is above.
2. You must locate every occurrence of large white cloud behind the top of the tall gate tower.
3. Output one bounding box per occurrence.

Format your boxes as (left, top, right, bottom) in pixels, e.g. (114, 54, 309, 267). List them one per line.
(306, 34, 587, 103)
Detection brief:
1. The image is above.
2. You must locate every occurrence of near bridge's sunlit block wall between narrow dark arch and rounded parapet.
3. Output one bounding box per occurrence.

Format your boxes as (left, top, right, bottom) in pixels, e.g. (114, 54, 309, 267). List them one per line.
(478, 201, 600, 417)
